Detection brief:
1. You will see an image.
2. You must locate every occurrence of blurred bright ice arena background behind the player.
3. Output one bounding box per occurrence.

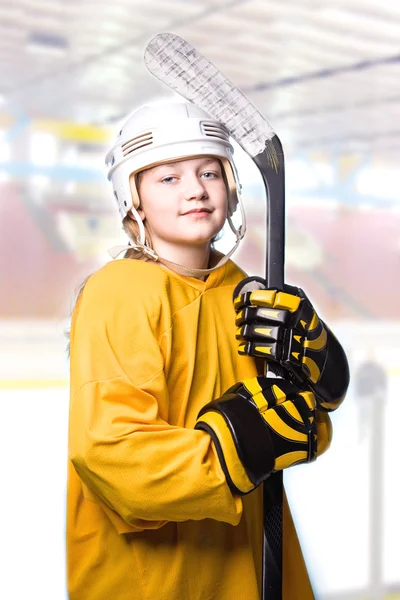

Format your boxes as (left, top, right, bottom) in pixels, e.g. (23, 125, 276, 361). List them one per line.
(0, 0, 400, 600)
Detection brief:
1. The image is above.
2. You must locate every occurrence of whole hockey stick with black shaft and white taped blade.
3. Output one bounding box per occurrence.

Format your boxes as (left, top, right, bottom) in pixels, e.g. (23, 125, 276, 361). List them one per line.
(144, 33, 285, 600)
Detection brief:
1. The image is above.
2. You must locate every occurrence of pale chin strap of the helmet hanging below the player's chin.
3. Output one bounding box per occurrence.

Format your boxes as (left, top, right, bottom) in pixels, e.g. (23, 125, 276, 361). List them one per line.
(108, 198, 246, 278)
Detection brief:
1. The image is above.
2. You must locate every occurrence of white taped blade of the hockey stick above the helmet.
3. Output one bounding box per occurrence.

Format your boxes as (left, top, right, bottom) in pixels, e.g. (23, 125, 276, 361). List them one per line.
(144, 33, 278, 159)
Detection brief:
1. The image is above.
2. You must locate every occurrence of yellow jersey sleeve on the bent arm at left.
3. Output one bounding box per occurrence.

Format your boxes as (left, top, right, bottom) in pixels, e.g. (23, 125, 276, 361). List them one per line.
(69, 262, 242, 531)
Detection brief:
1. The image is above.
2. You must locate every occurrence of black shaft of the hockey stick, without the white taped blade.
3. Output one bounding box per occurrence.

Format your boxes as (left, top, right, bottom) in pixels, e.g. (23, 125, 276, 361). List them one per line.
(253, 136, 285, 600)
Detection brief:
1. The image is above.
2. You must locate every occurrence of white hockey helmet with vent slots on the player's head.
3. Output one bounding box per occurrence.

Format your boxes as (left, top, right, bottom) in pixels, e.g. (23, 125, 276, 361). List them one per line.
(106, 103, 245, 258)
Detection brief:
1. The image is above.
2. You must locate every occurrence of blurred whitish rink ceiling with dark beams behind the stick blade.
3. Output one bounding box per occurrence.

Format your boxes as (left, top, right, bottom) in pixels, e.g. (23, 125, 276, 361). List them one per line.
(0, 0, 400, 152)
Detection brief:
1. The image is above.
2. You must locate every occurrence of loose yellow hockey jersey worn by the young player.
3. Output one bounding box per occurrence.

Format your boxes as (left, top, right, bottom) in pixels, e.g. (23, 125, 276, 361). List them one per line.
(67, 259, 313, 600)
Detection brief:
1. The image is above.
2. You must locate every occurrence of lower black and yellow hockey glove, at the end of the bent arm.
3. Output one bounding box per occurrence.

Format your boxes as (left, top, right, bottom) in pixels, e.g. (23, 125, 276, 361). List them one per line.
(195, 377, 332, 495)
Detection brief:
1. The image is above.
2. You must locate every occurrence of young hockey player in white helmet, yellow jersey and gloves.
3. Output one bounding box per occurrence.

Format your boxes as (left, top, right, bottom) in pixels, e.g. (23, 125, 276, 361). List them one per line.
(67, 104, 348, 600)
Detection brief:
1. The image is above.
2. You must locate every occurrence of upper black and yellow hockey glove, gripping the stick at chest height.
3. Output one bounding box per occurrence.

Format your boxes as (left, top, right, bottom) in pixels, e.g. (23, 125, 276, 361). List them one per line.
(234, 277, 349, 411)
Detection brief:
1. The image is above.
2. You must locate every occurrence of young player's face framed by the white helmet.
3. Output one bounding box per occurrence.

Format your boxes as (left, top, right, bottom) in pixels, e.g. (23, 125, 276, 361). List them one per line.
(134, 156, 228, 251)
